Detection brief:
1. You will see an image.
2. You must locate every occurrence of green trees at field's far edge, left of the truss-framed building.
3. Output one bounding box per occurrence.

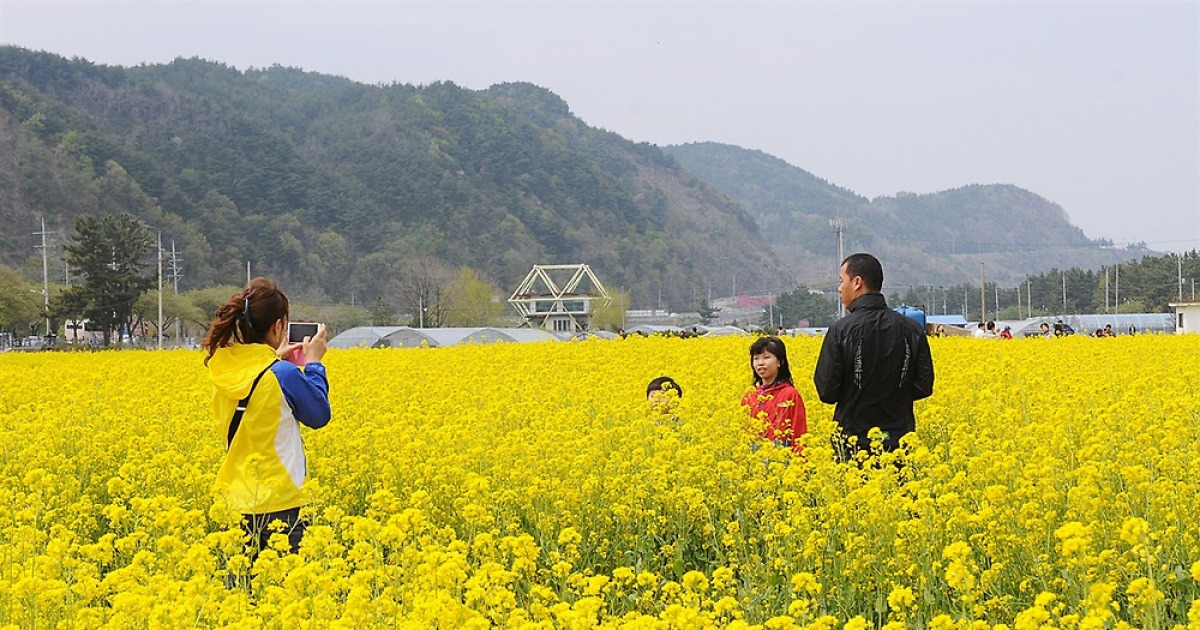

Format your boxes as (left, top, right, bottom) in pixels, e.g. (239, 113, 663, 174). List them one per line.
(0, 214, 512, 347)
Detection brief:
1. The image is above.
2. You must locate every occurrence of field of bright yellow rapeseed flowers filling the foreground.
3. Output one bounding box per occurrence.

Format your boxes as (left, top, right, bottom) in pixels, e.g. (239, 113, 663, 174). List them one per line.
(0, 336, 1200, 630)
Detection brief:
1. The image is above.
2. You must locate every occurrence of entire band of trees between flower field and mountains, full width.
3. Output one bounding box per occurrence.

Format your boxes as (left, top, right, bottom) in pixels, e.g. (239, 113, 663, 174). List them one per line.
(0, 220, 1200, 346)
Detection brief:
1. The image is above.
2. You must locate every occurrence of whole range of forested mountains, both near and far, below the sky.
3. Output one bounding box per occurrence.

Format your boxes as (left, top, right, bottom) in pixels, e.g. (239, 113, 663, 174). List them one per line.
(0, 47, 1140, 308)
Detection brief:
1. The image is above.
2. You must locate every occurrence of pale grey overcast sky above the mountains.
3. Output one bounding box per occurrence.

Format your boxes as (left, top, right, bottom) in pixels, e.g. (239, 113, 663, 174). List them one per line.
(0, 0, 1200, 251)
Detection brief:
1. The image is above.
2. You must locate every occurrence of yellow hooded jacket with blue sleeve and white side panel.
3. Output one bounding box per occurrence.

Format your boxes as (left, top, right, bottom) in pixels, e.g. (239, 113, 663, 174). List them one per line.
(209, 343, 330, 514)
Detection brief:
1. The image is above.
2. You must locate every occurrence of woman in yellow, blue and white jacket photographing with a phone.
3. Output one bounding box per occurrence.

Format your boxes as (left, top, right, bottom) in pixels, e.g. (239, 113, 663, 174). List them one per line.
(203, 277, 330, 553)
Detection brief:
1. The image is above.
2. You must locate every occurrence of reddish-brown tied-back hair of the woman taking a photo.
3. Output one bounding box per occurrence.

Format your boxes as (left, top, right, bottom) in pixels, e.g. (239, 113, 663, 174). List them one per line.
(200, 277, 288, 365)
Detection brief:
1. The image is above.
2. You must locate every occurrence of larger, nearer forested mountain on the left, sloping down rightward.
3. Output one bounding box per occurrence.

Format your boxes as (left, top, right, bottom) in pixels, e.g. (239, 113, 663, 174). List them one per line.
(0, 47, 787, 307)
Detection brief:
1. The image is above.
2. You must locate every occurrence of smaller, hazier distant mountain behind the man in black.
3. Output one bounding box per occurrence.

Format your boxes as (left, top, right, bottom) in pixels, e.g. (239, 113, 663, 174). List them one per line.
(664, 143, 1145, 287)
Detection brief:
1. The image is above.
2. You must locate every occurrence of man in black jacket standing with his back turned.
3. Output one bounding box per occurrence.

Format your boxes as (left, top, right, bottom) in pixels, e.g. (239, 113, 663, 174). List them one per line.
(812, 253, 934, 461)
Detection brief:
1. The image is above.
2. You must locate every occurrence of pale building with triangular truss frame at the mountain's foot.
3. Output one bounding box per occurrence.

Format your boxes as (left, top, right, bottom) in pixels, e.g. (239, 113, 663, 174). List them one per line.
(509, 264, 612, 332)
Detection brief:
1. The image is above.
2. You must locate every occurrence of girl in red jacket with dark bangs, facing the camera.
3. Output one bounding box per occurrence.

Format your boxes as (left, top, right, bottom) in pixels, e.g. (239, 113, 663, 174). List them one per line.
(742, 337, 809, 455)
